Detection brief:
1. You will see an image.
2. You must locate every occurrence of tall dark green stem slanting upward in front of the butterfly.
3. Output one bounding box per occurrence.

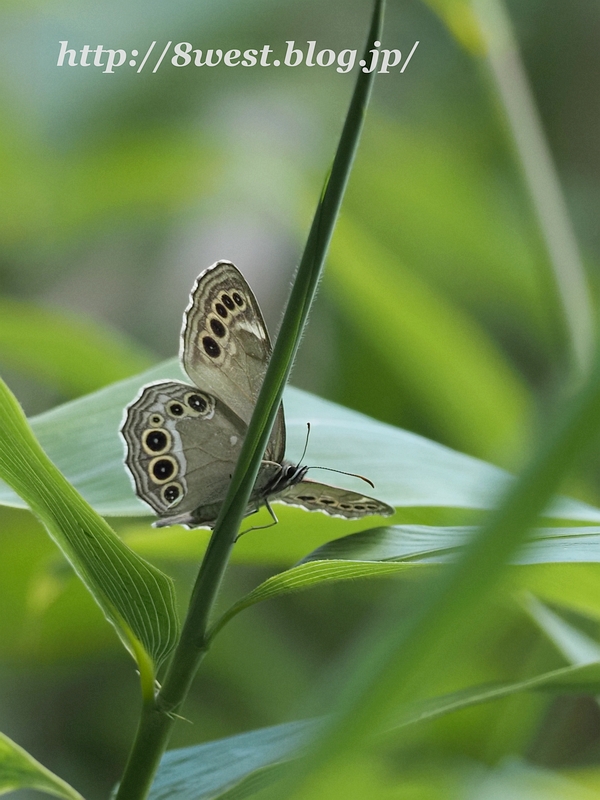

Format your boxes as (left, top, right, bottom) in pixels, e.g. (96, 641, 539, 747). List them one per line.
(117, 0, 384, 800)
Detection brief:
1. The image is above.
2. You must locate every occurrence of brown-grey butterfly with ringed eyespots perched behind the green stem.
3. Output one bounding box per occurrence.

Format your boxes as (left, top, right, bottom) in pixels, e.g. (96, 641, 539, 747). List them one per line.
(121, 261, 394, 528)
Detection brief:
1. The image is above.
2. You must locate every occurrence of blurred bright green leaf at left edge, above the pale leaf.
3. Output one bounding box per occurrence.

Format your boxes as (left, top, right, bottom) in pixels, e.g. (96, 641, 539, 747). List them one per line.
(0, 298, 153, 395)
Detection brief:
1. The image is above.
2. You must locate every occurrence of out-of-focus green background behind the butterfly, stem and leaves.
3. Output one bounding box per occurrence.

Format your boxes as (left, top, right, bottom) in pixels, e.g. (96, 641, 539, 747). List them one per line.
(0, 0, 600, 800)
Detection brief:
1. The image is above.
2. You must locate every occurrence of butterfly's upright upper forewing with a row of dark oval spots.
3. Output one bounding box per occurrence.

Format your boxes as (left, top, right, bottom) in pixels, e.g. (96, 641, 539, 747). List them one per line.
(181, 261, 285, 462)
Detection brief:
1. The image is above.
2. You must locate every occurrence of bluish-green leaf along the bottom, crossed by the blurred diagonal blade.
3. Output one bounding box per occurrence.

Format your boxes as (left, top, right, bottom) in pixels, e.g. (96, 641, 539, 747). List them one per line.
(149, 663, 600, 800)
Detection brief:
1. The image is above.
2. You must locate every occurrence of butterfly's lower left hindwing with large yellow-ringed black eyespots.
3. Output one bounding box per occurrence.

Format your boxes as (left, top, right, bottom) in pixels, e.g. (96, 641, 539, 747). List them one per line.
(121, 381, 246, 525)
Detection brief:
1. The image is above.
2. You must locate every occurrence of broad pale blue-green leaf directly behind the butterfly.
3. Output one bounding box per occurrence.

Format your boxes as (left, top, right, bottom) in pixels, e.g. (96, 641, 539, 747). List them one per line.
(0, 359, 600, 522)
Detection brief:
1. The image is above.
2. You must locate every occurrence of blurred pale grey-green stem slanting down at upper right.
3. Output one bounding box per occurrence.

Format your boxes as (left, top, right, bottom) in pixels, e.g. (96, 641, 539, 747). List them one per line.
(472, 0, 594, 377)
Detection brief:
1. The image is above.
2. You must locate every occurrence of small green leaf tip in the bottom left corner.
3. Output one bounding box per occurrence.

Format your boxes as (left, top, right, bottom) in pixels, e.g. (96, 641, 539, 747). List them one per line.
(0, 733, 83, 800)
